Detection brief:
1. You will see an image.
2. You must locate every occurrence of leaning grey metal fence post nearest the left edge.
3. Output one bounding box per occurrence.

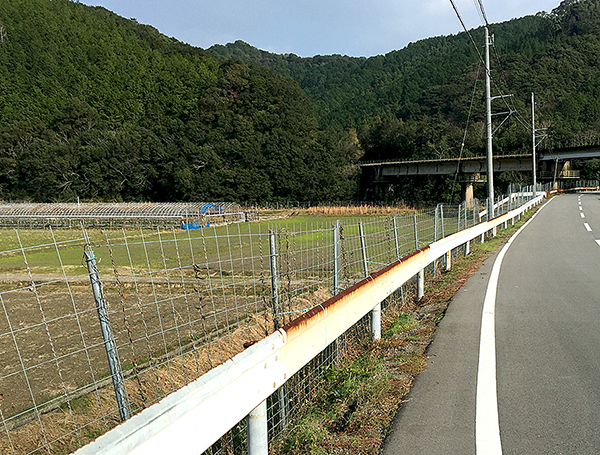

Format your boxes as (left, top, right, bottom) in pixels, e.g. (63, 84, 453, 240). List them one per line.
(85, 248, 131, 422)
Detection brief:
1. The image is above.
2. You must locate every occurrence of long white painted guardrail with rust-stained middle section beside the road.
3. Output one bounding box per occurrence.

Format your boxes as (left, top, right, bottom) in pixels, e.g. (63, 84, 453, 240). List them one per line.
(75, 196, 545, 455)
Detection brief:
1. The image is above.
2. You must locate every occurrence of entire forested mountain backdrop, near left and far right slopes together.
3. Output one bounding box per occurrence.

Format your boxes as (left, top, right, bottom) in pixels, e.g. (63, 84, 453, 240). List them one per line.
(0, 0, 600, 202)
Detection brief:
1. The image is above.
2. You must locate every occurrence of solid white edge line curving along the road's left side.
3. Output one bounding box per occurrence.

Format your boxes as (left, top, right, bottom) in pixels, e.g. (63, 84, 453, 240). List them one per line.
(475, 201, 552, 455)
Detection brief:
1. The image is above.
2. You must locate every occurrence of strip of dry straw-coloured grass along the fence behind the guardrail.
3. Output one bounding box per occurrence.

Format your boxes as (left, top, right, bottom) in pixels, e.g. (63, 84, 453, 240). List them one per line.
(0, 289, 338, 455)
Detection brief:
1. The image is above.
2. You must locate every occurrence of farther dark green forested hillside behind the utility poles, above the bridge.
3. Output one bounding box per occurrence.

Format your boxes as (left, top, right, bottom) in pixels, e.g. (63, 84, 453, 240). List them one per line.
(209, 0, 600, 167)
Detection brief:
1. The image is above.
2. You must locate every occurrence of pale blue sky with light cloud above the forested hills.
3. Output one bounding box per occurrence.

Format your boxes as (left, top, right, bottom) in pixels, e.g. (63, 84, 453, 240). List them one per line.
(81, 0, 560, 57)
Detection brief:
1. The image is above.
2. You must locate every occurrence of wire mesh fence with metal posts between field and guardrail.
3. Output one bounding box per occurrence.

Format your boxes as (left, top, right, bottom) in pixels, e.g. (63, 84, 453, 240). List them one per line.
(0, 192, 531, 455)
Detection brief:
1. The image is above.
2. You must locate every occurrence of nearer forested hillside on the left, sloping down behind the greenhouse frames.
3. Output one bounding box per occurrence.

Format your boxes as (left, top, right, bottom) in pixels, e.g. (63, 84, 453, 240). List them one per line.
(0, 0, 359, 202)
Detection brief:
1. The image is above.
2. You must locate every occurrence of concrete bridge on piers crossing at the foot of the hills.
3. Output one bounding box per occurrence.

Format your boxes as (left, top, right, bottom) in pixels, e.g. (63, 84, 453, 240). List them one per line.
(360, 146, 600, 201)
